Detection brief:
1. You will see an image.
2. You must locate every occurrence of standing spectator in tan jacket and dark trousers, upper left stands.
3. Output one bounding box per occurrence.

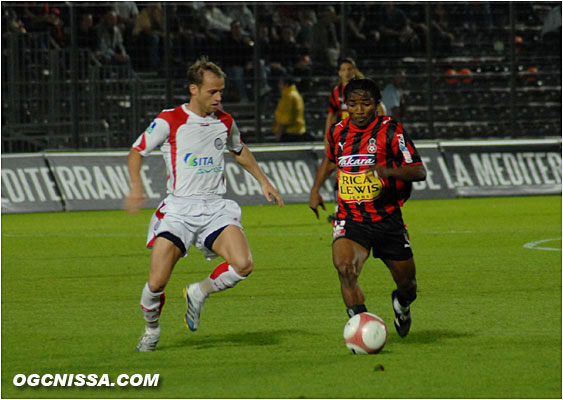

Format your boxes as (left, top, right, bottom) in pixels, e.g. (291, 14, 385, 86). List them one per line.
(133, 2, 164, 69)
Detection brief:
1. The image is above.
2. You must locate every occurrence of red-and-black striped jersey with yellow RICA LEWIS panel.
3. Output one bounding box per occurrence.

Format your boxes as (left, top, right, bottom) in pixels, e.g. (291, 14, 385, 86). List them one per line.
(327, 116, 422, 222)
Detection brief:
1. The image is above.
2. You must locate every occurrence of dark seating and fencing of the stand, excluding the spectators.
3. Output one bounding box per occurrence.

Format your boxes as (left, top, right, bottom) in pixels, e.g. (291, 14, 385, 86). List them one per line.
(2, 2, 561, 153)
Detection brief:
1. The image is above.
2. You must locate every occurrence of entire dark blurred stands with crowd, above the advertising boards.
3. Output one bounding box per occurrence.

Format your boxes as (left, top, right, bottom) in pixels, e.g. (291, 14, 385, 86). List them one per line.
(1, 1, 562, 153)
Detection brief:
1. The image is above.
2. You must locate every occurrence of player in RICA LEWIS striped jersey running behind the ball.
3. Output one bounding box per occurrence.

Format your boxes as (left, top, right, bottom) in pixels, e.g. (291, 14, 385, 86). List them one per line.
(309, 79, 426, 337)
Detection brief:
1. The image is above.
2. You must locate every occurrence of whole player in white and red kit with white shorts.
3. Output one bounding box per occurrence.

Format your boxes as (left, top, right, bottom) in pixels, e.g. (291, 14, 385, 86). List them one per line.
(125, 57, 284, 351)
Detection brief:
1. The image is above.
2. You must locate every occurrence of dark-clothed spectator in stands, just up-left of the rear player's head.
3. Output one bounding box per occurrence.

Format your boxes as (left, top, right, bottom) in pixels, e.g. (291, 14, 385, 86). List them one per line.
(312, 5, 340, 72)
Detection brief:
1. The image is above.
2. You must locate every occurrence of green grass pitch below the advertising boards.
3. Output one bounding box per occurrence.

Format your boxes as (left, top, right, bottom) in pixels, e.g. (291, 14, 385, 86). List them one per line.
(2, 196, 562, 398)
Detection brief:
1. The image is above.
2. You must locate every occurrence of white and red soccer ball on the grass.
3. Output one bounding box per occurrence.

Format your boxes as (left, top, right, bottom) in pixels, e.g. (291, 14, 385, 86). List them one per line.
(344, 312, 387, 354)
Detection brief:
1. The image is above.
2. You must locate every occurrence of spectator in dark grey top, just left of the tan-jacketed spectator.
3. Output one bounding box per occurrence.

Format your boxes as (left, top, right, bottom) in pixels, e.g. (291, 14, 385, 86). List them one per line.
(96, 10, 129, 65)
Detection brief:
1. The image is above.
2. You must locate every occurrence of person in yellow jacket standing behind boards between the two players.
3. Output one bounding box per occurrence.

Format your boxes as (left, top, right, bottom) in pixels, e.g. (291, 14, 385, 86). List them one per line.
(273, 75, 307, 142)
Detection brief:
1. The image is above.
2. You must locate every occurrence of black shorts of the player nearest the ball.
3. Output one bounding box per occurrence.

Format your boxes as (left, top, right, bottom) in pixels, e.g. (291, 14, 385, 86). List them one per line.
(332, 213, 413, 261)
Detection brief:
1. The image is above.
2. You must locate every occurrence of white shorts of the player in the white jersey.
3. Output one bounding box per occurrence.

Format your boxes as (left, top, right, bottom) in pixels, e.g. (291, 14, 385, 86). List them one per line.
(147, 195, 242, 260)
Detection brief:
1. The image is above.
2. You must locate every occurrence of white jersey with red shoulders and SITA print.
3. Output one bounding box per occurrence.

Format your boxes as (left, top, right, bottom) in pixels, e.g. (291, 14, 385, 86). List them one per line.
(133, 104, 244, 198)
